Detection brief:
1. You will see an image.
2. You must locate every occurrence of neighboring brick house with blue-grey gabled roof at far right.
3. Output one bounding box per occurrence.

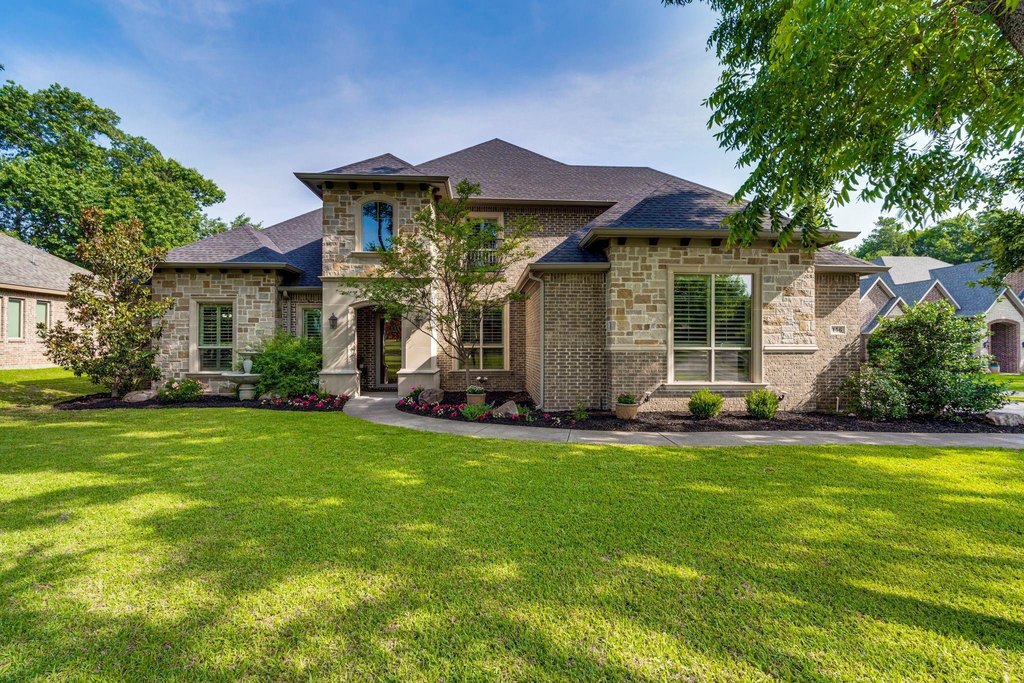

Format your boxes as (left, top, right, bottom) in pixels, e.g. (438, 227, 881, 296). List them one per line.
(860, 256, 1024, 373)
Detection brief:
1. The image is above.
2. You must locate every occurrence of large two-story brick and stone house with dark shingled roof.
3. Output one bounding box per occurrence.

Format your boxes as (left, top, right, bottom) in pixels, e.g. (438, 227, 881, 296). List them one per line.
(153, 139, 884, 410)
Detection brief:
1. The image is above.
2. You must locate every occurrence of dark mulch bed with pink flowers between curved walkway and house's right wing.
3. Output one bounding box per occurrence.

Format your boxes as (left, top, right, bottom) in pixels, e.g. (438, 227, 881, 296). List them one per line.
(397, 391, 1024, 434)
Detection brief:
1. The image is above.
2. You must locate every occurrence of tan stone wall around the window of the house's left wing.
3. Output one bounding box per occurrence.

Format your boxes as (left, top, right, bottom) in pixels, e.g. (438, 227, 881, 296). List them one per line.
(153, 268, 283, 392)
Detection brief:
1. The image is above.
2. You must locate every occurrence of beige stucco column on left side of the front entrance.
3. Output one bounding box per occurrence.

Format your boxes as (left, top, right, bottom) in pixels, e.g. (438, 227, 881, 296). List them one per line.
(321, 278, 359, 396)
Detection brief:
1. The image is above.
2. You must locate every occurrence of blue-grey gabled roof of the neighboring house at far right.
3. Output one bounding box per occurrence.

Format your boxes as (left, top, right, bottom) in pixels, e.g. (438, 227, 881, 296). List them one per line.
(860, 256, 1022, 332)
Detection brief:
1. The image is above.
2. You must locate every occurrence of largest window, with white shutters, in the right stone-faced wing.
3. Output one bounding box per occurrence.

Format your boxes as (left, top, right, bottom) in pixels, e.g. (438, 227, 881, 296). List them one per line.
(672, 273, 754, 382)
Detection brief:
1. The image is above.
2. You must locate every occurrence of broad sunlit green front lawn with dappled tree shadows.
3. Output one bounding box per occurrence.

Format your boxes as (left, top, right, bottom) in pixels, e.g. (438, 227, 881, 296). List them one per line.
(0, 409, 1024, 681)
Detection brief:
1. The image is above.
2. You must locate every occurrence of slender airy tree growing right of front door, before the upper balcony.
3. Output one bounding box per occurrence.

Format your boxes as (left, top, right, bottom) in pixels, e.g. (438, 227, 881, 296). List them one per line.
(344, 180, 537, 387)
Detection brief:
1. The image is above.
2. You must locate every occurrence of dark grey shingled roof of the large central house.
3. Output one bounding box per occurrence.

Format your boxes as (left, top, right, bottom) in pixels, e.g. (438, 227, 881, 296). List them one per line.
(168, 138, 873, 284)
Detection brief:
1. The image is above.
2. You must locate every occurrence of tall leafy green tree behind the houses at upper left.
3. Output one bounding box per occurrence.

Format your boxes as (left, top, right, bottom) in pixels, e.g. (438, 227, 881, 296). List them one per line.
(0, 67, 224, 259)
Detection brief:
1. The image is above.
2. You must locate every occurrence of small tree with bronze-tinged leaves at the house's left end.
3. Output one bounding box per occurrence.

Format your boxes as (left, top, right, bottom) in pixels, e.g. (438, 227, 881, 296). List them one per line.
(39, 209, 172, 397)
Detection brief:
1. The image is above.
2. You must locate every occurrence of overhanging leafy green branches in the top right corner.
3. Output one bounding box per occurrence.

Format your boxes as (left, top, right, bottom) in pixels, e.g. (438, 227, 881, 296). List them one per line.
(664, 0, 1024, 253)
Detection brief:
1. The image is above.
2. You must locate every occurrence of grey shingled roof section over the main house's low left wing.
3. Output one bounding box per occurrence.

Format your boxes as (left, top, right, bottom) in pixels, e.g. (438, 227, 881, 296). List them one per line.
(164, 209, 324, 287)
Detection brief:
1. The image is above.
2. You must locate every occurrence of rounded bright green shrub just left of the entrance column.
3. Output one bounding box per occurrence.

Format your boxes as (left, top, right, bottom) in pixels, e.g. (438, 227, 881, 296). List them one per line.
(247, 332, 322, 397)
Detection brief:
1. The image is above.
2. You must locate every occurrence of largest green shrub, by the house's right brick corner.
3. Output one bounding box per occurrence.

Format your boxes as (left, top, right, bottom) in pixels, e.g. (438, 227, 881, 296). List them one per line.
(867, 301, 1002, 418)
